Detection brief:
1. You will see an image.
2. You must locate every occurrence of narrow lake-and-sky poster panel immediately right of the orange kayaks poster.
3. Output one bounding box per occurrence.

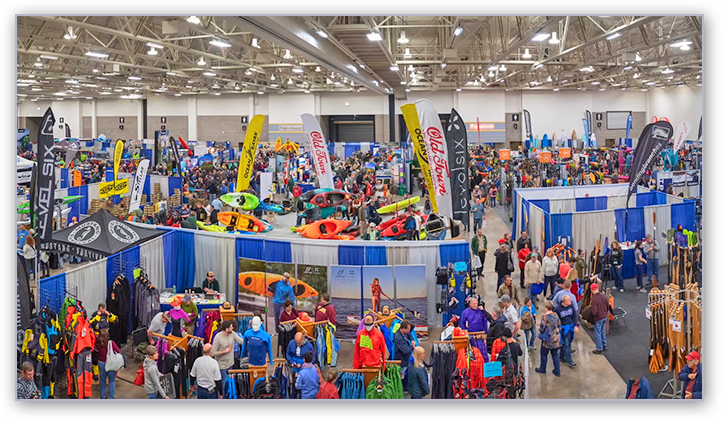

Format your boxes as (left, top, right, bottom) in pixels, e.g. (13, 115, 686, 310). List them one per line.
(329, 265, 362, 340)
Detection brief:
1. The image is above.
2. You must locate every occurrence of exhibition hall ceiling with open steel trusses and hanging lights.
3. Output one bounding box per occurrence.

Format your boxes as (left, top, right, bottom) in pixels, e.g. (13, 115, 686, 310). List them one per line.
(16, 16, 703, 100)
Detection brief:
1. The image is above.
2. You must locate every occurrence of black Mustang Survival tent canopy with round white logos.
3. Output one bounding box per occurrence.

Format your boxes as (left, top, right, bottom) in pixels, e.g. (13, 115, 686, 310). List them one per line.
(40, 209, 163, 260)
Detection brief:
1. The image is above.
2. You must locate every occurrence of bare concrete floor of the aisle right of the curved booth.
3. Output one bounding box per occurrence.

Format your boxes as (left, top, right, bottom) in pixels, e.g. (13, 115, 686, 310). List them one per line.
(468, 203, 626, 399)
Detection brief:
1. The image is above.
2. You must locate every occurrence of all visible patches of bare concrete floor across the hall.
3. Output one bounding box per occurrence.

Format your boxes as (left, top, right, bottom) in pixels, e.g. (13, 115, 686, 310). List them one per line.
(36, 195, 626, 399)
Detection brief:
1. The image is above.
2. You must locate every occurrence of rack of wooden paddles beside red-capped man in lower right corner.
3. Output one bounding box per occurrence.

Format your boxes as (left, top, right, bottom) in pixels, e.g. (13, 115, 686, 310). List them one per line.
(645, 283, 703, 399)
